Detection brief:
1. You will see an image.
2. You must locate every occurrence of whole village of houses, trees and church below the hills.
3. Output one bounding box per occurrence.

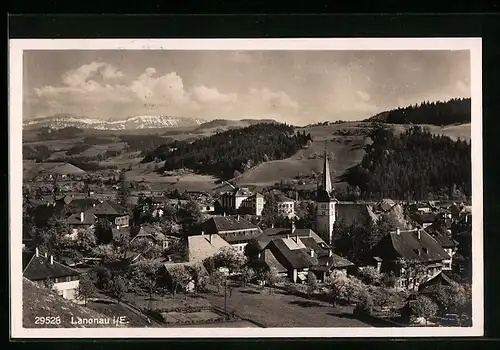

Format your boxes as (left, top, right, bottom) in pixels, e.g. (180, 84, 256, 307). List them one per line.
(23, 144, 472, 327)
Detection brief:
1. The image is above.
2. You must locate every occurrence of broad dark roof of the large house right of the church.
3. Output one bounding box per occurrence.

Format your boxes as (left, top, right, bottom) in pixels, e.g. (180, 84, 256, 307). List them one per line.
(372, 229, 450, 262)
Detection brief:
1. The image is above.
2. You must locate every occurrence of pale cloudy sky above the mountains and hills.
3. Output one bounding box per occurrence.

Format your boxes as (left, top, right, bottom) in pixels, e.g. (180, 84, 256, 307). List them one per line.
(23, 50, 470, 125)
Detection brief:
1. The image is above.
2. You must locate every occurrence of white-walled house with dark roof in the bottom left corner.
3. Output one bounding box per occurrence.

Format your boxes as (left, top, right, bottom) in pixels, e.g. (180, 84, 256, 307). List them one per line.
(23, 248, 80, 301)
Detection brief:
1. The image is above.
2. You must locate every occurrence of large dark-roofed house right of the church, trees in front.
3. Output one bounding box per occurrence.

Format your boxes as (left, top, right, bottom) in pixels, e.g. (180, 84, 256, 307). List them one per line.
(369, 229, 451, 289)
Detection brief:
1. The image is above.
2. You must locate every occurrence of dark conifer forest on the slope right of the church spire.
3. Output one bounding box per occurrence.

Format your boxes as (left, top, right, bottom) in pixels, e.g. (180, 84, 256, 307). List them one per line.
(344, 126, 472, 200)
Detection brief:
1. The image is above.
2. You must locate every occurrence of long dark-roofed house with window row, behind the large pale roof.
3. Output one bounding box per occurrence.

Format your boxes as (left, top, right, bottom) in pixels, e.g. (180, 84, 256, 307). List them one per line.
(202, 215, 262, 252)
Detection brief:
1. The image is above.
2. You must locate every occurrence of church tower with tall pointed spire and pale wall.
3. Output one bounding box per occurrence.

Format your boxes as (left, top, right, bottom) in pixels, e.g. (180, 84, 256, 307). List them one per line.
(316, 142, 337, 243)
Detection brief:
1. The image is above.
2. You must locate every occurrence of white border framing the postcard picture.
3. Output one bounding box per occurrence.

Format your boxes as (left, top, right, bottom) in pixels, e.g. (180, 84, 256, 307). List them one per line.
(9, 38, 484, 339)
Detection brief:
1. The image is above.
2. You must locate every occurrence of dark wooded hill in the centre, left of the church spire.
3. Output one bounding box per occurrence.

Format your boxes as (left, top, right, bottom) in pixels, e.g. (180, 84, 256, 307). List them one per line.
(143, 123, 311, 179)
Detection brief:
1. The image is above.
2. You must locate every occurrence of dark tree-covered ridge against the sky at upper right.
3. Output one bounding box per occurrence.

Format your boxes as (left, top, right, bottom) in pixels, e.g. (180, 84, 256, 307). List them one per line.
(366, 98, 471, 126)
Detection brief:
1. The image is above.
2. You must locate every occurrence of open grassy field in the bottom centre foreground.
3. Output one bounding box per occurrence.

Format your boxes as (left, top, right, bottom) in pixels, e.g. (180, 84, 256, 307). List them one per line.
(203, 286, 371, 327)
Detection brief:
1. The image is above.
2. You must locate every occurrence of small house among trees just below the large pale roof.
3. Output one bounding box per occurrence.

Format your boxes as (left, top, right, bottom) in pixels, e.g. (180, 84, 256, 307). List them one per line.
(163, 262, 208, 293)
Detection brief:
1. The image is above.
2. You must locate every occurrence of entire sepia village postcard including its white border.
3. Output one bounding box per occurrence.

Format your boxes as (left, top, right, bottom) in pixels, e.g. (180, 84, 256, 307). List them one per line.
(9, 38, 483, 338)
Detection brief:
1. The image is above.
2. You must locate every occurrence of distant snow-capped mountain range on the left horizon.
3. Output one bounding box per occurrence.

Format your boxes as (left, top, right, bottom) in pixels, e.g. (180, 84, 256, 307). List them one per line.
(23, 114, 206, 130)
